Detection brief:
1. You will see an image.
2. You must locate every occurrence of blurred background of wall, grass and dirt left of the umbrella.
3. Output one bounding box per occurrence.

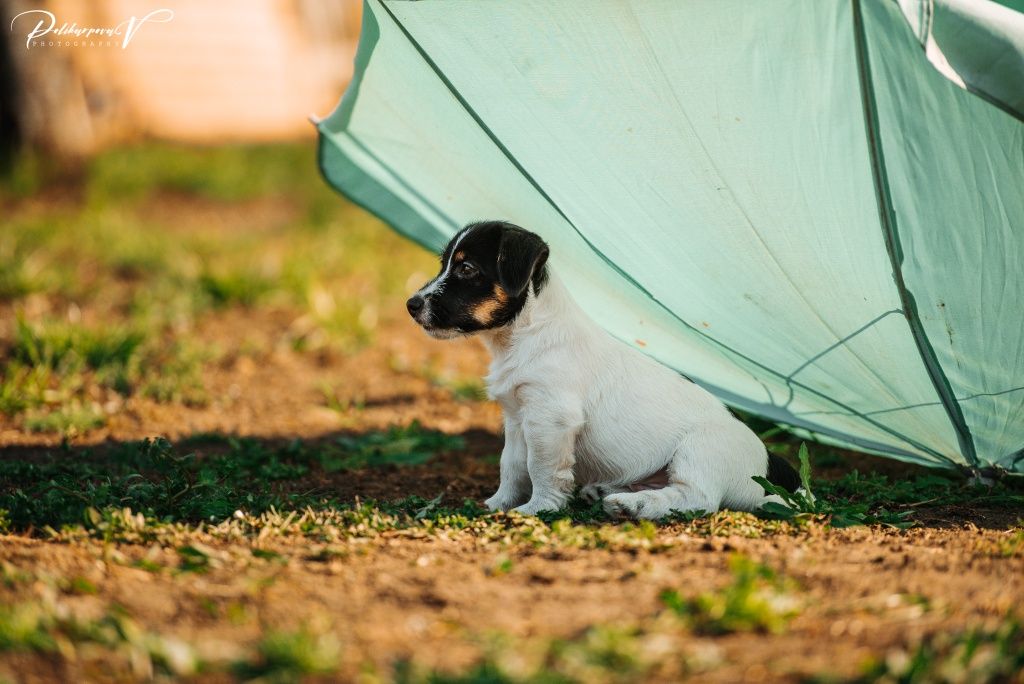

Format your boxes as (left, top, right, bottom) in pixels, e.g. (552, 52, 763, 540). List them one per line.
(0, 0, 500, 446)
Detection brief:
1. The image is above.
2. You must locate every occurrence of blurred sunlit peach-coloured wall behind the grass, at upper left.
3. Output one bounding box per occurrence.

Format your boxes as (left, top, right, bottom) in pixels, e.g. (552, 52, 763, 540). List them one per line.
(0, 0, 361, 157)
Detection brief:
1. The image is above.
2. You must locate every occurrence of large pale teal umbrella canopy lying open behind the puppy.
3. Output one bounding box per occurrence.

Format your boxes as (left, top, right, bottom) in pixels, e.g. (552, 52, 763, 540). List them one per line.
(318, 0, 1024, 471)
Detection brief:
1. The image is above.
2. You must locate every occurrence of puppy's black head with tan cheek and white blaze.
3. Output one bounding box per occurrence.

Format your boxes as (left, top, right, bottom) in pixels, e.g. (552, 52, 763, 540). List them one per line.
(406, 221, 548, 339)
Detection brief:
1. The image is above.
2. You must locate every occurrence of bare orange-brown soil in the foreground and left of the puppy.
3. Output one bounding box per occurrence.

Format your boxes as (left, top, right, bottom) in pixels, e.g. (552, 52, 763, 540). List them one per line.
(0, 309, 1024, 682)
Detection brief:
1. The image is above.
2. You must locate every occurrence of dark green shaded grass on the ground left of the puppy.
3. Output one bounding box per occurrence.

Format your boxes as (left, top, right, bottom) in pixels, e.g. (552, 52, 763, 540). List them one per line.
(0, 423, 462, 529)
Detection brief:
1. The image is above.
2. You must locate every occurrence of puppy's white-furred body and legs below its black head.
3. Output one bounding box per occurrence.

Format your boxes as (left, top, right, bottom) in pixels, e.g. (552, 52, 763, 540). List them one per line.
(481, 275, 779, 519)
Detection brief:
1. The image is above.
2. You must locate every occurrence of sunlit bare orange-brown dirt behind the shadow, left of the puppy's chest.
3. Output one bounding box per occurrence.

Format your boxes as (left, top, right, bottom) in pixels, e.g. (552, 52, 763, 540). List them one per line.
(0, 310, 501, 452)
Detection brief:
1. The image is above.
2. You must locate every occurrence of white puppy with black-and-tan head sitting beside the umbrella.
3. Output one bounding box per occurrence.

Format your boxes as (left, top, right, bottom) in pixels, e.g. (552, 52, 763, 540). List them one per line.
(407, 221, 799, 519)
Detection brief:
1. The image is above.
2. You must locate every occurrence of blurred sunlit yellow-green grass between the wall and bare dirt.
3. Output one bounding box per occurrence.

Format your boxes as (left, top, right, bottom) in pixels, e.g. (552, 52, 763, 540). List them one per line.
(0, 143, 436, 435)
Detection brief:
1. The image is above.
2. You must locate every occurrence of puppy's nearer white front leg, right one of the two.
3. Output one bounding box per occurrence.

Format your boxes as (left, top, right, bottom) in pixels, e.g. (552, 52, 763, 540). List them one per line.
(515, 397, 583, 515)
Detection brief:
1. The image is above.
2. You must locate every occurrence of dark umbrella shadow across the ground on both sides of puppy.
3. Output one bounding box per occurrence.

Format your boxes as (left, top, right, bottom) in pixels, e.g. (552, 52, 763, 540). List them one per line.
(0, 422, 1024, 531)
